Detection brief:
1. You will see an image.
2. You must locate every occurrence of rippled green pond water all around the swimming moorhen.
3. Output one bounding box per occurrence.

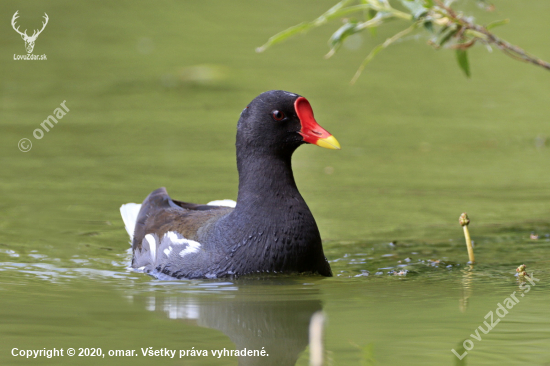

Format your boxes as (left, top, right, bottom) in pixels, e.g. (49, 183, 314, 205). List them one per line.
(0, 0, 550, 366)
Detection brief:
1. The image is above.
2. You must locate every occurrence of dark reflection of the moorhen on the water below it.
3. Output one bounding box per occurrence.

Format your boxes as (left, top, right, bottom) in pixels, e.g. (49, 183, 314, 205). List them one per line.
(140, 283, 322, 366)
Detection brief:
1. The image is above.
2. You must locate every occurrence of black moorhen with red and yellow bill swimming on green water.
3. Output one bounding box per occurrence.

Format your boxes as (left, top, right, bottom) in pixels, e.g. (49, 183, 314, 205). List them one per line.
(120, 90, 340, 279)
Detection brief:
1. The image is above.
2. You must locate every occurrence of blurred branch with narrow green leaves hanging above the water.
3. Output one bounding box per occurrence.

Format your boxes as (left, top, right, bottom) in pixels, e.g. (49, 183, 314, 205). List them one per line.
(256, 0, 550, 84)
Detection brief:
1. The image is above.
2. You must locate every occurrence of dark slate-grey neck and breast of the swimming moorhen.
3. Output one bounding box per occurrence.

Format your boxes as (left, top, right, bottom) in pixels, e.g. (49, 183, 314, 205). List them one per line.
(213, 139, 331, 276)
